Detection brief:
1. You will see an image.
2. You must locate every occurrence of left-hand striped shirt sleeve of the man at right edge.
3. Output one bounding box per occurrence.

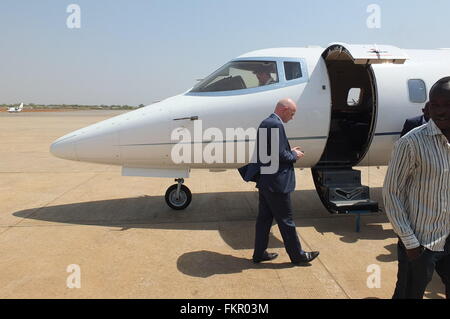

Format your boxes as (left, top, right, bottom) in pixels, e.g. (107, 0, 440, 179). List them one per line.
(383, 138, 420, 249)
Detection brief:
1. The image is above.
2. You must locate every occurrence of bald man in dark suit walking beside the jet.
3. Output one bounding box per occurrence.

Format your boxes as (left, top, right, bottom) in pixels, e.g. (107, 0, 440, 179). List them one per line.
(239, 99, 319, 264)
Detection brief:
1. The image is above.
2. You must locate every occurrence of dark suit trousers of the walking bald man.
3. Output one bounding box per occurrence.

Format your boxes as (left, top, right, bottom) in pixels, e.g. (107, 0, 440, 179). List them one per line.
(253, 188, 304, 262)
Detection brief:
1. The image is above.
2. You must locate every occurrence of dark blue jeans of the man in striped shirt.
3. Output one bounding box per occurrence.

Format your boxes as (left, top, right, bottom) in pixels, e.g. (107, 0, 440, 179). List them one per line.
(392, 236, 450, 299)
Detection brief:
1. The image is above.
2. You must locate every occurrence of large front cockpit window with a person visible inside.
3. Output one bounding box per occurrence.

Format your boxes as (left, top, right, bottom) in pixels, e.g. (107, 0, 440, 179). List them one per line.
(191, 61, 278, 92)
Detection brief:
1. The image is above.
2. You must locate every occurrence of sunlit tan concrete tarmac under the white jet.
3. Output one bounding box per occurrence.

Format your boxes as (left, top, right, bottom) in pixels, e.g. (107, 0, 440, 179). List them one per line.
(0, 111, 444, 299)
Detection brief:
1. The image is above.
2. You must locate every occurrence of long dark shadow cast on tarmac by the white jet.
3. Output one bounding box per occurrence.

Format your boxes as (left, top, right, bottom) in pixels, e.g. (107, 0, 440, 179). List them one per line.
(13, 189, 395, 251)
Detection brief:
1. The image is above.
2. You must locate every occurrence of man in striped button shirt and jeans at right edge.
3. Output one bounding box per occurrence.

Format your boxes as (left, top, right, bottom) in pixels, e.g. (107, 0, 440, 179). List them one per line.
(383, 77, 450, 298)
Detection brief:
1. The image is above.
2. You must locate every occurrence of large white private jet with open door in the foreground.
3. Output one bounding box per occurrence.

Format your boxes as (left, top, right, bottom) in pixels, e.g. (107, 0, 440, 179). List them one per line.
(50, 43, 450, 213)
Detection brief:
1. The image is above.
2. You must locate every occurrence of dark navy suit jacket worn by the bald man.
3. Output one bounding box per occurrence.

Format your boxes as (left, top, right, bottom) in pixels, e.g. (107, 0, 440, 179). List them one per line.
(239, 114, 297, 193)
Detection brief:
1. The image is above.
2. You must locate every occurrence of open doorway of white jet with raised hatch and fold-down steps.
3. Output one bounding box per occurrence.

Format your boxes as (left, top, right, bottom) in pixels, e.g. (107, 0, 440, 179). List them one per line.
(311, 43, 407, 213)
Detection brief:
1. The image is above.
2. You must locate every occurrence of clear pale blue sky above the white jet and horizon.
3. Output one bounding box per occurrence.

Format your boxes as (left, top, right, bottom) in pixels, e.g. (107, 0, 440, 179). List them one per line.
(0, 0, 450, 105)
